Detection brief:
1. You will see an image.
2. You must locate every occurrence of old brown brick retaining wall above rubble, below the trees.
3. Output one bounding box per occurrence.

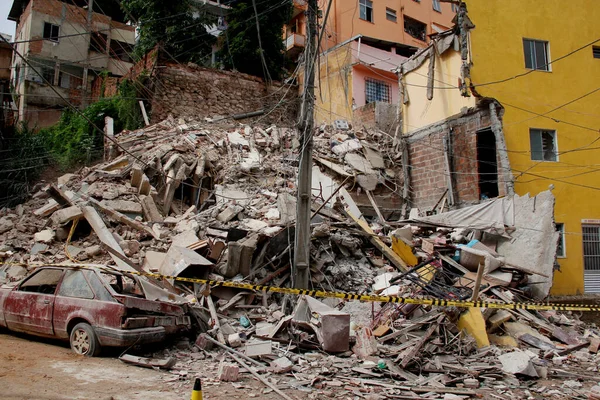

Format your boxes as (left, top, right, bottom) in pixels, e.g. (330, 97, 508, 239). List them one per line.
(92, 47, 299, 125)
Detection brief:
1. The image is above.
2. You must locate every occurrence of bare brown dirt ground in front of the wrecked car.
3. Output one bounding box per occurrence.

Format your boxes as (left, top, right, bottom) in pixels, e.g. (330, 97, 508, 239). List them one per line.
(0, 331, 305, 400)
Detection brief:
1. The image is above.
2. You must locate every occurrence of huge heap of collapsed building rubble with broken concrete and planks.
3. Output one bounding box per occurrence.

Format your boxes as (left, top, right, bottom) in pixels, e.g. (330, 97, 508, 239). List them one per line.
(0, 114, 600, 399)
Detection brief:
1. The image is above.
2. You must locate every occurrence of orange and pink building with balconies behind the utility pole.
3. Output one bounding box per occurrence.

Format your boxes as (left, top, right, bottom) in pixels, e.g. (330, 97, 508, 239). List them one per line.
(284, 0, 456, 130)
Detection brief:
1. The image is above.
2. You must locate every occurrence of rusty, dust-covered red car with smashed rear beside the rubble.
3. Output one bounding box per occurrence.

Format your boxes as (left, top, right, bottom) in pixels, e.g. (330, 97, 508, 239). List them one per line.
(0, 267, 190, 356)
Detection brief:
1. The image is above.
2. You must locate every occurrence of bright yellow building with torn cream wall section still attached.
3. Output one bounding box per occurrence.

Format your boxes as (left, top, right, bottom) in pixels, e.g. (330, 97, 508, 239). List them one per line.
(401, 0, 600, 295)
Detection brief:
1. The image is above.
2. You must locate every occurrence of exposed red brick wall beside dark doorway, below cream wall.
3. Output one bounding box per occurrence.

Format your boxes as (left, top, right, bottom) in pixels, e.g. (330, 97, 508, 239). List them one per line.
(406, 107, 506, 210)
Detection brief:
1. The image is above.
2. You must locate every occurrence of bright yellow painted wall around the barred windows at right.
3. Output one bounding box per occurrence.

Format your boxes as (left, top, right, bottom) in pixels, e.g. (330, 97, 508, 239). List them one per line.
(466, 0, 600, 295)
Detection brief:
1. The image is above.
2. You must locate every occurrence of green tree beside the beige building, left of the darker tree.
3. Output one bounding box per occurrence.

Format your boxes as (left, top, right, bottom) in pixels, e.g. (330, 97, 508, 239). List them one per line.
(121, 0, 217, 64)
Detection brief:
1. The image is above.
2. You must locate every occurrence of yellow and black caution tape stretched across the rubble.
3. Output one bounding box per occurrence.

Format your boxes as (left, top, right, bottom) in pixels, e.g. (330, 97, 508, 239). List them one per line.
(0, 263, 600, 312)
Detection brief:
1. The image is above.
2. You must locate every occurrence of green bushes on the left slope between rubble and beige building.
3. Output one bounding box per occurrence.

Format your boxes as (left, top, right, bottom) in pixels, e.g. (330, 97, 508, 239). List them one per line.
(0, 78, 145, 207)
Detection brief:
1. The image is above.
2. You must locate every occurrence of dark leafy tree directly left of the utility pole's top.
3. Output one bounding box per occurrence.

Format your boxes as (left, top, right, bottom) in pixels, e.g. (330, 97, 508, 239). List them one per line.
(219, 0, 292, 79)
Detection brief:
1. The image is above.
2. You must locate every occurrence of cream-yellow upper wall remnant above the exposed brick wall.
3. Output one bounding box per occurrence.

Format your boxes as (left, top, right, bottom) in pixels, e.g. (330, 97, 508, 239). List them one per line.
(402, 49, 475, 133)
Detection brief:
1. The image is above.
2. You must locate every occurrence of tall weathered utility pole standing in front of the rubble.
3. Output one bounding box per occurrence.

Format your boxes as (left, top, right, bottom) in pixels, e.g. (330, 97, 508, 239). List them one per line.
(292, 0, 319, 289)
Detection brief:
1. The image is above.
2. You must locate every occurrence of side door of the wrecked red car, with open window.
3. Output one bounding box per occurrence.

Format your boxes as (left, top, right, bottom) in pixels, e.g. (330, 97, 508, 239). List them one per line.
(4, 268, 63, 336)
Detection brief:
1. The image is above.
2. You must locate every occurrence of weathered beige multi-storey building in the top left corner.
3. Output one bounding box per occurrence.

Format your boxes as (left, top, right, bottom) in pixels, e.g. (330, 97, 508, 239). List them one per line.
(8, 0, 135, 128)
